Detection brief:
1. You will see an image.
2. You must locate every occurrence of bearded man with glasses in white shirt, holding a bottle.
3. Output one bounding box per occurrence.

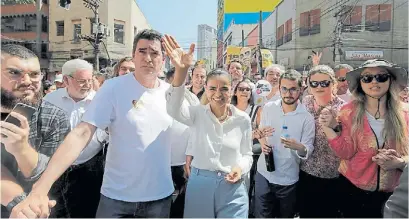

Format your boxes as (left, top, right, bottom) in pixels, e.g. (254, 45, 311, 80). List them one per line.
(254, 71, 315, 218)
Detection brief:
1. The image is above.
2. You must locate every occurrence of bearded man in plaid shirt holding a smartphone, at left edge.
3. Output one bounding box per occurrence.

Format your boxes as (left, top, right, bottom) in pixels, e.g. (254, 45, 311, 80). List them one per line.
(0, 44, 69, 218)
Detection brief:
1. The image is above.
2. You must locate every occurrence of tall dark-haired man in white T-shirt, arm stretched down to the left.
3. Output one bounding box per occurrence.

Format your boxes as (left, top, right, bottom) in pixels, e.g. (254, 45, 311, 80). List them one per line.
(13, 30, 178, 218)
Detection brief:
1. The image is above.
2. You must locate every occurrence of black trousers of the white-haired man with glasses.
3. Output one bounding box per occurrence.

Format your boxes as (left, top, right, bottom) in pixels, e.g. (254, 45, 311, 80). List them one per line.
(59, 151, 105, 218)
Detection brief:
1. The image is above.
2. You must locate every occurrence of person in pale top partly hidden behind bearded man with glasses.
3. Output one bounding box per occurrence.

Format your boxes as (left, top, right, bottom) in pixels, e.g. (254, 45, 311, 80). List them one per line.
(253, 64, 285, 106)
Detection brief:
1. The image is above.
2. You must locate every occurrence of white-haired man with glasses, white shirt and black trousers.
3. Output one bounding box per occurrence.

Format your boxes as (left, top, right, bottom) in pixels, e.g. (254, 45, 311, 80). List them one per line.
(44, 59, 106, 218)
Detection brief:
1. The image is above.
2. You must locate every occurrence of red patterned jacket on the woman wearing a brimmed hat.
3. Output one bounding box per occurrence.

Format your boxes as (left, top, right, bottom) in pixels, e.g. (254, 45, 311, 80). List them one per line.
(328, 102, 409, 192)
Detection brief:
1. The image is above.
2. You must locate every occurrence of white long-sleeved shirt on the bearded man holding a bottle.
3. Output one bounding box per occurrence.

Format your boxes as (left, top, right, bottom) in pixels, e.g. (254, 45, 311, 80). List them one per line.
(257, 100, 315, 186)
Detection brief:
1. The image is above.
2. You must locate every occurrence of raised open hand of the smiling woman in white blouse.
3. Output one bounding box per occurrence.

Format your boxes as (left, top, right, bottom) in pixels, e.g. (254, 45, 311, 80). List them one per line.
(162, 35, 195, 69)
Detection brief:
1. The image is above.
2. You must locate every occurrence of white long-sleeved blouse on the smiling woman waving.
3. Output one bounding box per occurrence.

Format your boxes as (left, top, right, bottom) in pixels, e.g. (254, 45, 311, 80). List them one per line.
(166, 85, 253, 175)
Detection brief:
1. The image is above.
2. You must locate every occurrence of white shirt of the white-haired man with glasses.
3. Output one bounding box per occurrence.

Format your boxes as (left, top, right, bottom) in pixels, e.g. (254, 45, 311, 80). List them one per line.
(44, 88, 107, 165)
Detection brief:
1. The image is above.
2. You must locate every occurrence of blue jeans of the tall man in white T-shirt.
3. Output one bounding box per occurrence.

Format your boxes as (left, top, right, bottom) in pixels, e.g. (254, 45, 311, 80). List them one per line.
(97, 195, 172, 218)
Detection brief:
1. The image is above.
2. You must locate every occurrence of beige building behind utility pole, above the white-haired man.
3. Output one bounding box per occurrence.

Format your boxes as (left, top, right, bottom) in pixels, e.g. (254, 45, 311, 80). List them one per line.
(49, 0, 150, 72)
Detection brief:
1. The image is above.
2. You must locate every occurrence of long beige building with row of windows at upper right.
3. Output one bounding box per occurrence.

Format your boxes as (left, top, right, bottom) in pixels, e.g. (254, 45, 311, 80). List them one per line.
(256, 0, 408, 71)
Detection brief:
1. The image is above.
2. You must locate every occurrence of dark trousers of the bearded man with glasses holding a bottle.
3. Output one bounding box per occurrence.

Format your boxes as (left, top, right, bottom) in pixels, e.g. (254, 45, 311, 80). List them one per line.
(254, 173, 297, 218)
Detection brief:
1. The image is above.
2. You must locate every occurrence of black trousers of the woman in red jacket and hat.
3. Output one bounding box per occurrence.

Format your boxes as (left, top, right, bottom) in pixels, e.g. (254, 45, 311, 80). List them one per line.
(339, 176, 392, 218)
